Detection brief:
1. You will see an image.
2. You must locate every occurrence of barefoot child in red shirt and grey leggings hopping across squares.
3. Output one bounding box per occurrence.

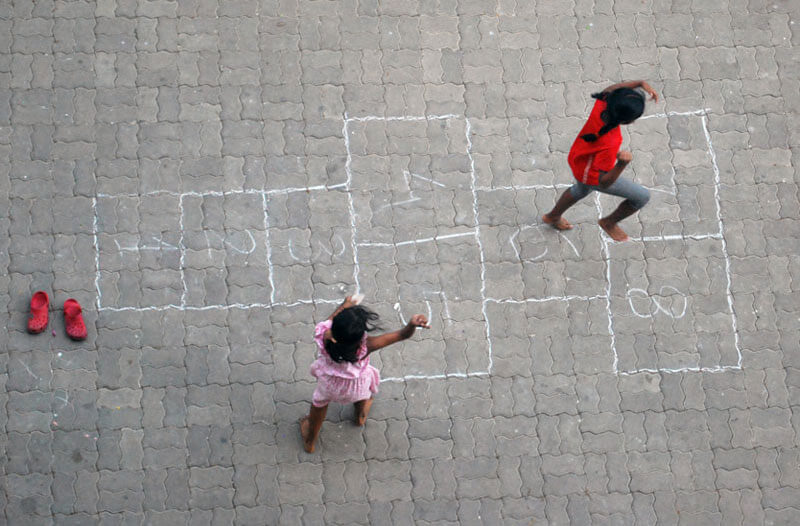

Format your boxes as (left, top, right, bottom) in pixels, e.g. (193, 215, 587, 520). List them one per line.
(542, 80, 658, 241)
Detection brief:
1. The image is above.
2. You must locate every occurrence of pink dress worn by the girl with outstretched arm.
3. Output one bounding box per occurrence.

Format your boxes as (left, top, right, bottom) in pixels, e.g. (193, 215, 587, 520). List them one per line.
(311, 320, 381, 407)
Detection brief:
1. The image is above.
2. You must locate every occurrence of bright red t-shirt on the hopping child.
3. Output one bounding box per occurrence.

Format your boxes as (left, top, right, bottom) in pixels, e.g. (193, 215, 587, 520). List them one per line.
(567, 100, 622, 186)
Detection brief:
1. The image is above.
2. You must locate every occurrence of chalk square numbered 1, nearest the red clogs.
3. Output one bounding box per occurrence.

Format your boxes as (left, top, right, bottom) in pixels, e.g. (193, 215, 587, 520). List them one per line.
(96, 193, 183, 309)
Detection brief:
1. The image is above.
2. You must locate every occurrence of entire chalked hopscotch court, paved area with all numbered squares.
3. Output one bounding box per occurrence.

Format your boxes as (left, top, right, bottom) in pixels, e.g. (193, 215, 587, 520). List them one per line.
(94, 111, 741, 381)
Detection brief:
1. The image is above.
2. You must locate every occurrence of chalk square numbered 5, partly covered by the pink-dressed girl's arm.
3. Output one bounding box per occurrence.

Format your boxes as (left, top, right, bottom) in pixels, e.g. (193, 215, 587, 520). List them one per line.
(358, 240, 490, 384)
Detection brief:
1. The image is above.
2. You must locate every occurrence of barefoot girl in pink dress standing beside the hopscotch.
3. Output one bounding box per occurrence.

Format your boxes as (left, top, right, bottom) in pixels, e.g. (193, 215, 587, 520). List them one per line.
(300, 296, 429, 453)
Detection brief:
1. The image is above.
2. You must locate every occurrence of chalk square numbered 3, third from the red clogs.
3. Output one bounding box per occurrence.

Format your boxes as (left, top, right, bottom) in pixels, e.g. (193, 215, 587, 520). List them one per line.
(267, 189, 355, 304)
